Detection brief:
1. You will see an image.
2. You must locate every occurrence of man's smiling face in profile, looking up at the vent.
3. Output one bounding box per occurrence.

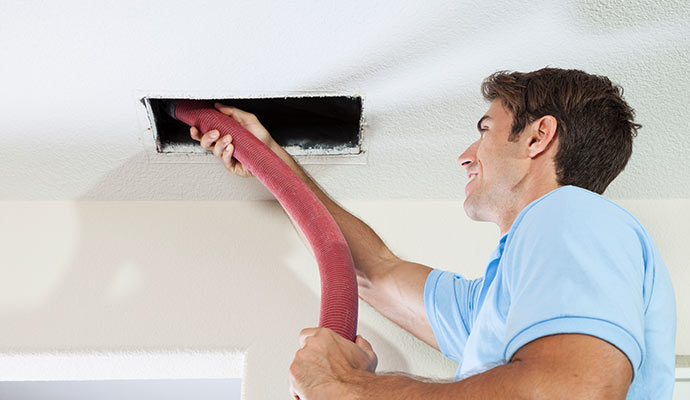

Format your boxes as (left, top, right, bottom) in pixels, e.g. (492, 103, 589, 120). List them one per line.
(458, 100, 524, 222)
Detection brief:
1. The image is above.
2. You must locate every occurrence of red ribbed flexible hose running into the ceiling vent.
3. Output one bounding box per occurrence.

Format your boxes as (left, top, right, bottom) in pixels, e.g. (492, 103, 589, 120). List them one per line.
(174, 100, 357, 341)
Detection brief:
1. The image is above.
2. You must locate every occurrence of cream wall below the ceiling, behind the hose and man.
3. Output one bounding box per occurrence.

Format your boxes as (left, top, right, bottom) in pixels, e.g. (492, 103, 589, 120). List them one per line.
(0, 200, 690, 399)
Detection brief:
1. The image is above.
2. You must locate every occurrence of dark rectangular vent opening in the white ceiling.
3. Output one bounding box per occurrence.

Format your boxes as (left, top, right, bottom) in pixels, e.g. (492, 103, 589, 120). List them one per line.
(143, 96, 362, 156)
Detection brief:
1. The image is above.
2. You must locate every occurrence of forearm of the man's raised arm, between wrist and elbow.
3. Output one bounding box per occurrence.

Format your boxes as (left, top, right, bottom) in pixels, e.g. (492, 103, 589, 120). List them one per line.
(271, 144, 394, 279)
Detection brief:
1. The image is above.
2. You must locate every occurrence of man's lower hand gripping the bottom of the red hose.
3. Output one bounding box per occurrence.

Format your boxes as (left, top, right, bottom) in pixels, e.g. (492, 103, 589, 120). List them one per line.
(290, 328, 378, 400)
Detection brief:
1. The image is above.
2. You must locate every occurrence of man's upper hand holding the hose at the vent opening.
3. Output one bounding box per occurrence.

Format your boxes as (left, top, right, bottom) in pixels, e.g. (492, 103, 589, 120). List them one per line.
(190, 103, 278, 178)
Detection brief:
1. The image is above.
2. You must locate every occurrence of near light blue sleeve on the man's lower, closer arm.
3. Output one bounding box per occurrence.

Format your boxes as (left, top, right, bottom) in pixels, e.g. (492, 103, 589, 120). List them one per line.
(504, 202, 645, 373)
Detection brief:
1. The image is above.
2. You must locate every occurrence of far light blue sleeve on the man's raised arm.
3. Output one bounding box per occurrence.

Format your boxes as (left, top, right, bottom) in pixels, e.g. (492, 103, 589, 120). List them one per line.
(424, 269, 484, 363)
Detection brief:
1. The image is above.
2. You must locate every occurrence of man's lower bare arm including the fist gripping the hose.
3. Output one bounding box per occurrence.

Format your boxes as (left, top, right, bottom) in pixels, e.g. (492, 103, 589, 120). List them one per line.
(290, 330, 632, 400)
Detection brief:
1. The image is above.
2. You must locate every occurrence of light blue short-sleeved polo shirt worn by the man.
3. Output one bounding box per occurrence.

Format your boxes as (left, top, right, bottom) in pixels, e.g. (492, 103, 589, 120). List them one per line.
(424, 186, 676, 399)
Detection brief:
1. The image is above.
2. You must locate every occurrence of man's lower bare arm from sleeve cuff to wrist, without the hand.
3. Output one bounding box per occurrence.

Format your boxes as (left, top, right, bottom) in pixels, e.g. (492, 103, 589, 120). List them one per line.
(354, 334, 632, 400)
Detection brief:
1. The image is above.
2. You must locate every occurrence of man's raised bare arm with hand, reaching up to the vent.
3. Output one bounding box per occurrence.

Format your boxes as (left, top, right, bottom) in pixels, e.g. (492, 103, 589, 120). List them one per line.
(191, 104, 438, 349)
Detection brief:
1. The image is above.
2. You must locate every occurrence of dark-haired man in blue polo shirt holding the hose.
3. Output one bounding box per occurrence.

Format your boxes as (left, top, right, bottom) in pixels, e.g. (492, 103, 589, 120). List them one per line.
(191, 68, 676, 400)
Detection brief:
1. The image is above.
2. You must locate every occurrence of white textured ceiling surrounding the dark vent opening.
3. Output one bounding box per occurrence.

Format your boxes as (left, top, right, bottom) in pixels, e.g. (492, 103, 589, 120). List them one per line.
(0, 0, 690, 200)
